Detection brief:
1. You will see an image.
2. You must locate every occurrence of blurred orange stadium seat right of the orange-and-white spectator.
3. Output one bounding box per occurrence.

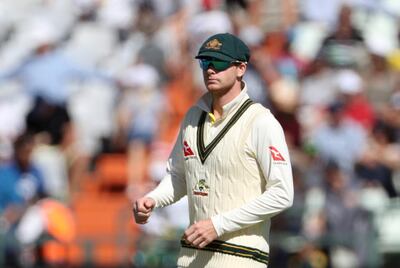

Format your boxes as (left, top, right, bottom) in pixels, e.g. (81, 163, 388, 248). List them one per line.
(69, 193, 138, 267)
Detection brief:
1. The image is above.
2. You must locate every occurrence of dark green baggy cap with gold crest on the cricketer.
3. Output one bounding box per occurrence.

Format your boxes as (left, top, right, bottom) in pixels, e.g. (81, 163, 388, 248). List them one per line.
(195, 33, 250, 62)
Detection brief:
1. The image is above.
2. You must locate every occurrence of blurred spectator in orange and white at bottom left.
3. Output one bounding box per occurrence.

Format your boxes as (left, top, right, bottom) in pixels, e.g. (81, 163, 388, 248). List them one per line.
(15, 198, 76, 267)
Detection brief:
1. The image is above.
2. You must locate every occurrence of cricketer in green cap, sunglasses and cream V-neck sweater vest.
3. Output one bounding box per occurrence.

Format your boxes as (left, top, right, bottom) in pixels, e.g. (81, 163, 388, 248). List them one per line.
(133, 33, 293, 267)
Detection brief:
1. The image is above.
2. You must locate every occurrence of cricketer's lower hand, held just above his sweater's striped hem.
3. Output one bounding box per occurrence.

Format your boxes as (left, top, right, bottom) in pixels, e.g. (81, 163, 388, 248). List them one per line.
(183, 219, 218, 248)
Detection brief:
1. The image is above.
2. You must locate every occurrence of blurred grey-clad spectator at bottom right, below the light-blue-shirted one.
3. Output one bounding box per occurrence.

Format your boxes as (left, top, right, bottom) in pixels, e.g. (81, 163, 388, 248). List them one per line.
(323, 162, 372, 267)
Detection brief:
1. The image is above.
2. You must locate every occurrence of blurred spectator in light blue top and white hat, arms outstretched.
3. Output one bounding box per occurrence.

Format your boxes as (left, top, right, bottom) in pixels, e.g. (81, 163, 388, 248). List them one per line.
(0, 22, 111, 147)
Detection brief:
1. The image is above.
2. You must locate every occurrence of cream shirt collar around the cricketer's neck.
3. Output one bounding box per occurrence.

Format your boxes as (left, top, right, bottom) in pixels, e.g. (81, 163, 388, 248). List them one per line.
(196, 81, 249, 118)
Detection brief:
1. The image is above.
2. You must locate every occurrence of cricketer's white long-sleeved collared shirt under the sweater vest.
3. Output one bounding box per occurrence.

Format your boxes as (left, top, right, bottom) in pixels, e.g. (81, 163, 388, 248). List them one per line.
(147, 81, 293, 236)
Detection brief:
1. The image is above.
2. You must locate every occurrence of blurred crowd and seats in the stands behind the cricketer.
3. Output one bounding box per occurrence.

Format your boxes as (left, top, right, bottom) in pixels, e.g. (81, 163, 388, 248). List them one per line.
(0, 0, 400, 268)
